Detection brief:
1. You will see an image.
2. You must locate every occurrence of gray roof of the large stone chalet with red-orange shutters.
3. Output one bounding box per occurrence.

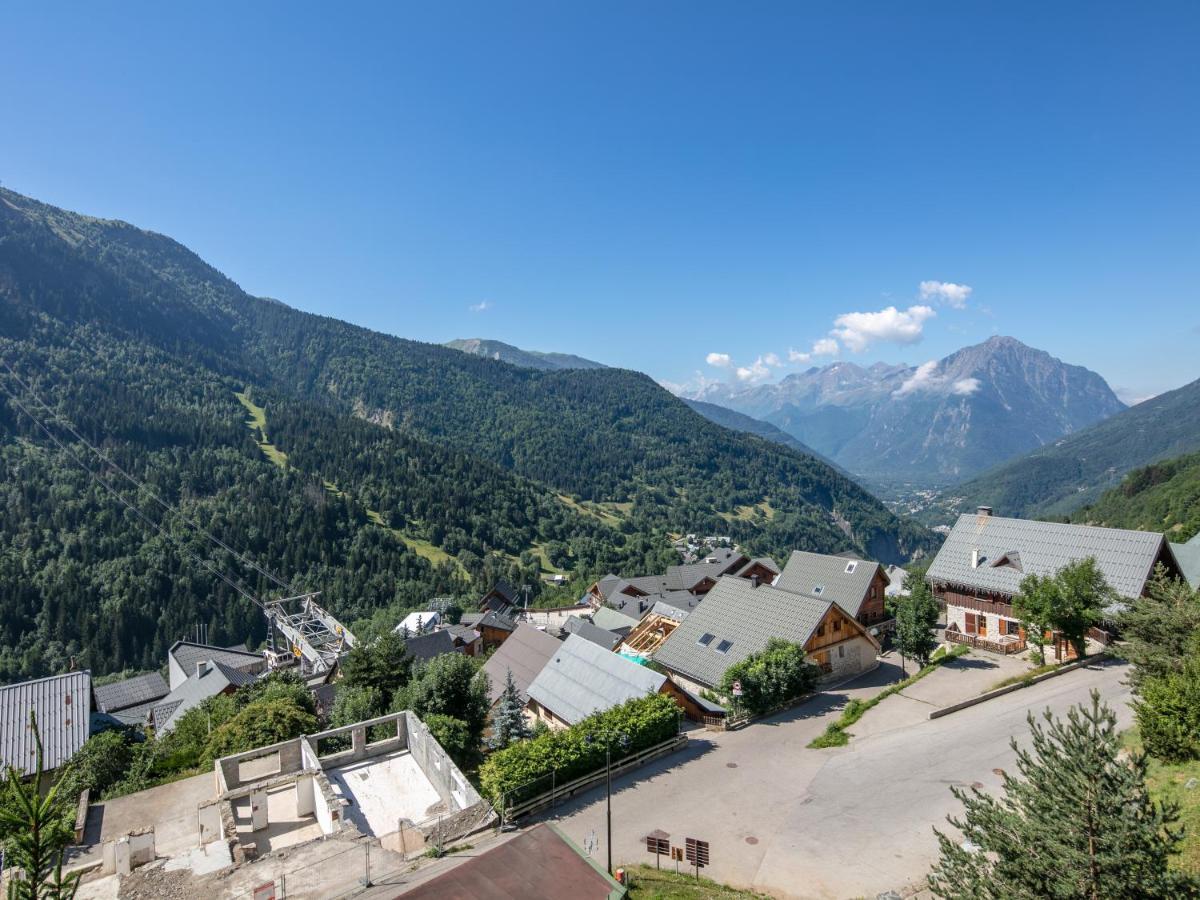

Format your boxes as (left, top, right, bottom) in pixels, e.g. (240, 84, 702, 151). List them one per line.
(925, 512, 1165, 598)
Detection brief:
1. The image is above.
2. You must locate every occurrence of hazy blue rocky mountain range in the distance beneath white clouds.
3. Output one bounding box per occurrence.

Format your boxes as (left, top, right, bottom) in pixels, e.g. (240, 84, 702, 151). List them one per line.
(688, 336, 1126, 485)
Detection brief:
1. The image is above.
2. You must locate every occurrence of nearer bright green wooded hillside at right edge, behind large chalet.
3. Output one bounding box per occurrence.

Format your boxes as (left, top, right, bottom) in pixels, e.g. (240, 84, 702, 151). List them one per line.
(1070, 454, 1200, 544)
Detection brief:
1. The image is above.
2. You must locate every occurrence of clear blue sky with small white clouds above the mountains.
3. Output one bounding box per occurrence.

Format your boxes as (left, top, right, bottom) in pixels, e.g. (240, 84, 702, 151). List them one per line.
(0, 2, 1200, 397)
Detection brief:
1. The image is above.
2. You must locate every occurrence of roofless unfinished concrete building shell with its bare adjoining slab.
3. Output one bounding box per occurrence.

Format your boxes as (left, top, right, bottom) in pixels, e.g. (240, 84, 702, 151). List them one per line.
(74, 712, 496, 896)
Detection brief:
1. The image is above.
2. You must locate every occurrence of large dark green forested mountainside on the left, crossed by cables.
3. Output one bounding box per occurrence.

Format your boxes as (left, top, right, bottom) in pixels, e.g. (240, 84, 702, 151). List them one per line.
(0, 191, 936, 678)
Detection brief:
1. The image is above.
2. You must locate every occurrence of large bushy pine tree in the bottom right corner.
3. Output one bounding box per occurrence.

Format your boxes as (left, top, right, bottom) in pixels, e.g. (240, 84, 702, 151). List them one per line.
(929, 691, 1200, 900)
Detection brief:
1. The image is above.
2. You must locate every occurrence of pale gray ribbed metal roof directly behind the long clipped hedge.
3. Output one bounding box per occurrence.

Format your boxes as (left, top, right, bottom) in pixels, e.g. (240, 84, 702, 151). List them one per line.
(529, 635, 666, 725)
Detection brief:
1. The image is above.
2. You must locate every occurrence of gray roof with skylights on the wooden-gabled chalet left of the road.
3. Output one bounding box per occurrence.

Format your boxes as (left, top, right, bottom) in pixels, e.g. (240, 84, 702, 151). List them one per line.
(654, 575, 848, 686)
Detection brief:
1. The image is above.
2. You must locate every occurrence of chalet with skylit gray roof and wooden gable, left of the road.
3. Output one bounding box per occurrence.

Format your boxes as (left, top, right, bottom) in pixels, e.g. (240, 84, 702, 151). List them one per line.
(654, 577, 880, 692)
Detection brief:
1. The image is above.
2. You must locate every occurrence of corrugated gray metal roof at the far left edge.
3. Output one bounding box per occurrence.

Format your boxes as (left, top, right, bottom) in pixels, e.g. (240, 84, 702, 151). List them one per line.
(0, 671, 91, 772)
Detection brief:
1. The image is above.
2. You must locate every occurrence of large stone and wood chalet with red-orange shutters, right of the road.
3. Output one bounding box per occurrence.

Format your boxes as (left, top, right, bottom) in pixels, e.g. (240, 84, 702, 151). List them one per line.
(925, 506, 1181, 653)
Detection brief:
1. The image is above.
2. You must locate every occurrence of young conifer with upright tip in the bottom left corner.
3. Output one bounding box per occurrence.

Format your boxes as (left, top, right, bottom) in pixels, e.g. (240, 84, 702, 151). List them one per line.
(0, 710, 79, 900)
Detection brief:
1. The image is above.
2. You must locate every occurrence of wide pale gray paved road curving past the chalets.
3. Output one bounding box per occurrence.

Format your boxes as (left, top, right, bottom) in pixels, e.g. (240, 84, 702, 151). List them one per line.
(553, 662, 1132, 898)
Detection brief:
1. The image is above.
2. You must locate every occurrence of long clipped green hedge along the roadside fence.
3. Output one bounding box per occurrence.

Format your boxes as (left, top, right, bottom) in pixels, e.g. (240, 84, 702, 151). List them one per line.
(479, 694, 679, 806)
